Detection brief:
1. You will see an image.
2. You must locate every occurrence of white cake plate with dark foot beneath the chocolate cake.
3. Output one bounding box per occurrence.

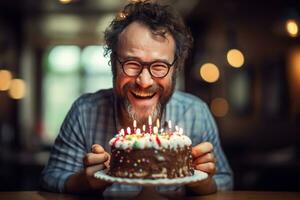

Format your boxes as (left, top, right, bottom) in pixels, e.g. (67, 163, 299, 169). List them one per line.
(94, 170, 208, 200)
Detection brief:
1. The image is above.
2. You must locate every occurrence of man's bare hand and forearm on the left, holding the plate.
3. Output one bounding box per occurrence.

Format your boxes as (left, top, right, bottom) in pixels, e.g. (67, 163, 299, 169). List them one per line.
(65, 144, 111, 193)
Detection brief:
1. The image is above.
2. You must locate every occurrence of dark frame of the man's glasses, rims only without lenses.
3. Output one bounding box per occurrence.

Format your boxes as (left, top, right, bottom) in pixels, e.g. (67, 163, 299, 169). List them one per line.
(116, 55, 177, 78)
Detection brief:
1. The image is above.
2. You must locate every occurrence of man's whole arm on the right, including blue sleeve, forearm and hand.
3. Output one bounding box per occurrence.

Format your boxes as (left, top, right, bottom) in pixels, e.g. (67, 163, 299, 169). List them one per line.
(186, 103, 233, 194)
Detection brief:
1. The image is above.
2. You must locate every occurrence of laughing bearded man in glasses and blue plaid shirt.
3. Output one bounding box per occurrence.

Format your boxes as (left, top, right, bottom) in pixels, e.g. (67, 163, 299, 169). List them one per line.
(42, 1, 232, 194)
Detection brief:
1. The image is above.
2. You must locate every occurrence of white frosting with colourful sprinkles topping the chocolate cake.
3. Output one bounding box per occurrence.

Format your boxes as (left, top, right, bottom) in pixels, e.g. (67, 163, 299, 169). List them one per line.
(109, 130, 192, 149)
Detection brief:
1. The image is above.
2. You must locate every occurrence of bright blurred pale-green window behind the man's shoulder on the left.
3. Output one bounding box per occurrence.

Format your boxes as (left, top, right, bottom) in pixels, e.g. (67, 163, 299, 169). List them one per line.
(42, 45, 112, 144)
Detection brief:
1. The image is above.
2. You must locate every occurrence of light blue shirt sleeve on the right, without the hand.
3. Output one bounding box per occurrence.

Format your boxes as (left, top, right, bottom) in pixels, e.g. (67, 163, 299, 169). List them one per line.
(192, 103, 233, 191)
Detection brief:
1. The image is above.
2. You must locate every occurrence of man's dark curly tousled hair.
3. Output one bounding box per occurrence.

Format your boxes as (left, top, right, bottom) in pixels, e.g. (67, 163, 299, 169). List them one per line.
(104, 0, 193, 76)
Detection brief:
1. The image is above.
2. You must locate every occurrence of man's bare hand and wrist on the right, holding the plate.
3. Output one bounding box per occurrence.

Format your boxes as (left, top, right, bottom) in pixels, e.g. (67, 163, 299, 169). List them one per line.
(186, 142, 217, 194)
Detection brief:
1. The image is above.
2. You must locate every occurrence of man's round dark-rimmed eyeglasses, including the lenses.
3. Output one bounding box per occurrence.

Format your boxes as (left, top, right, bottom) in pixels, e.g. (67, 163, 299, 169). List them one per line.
(116, 56, 177, 78)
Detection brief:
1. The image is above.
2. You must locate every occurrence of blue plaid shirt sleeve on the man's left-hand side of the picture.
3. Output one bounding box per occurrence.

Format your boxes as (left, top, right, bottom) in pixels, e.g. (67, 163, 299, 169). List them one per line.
(41, 100, 87, 192)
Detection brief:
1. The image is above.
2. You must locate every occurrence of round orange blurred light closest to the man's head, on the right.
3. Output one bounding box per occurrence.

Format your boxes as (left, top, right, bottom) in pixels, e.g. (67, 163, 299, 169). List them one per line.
(200, 63, 220, 83)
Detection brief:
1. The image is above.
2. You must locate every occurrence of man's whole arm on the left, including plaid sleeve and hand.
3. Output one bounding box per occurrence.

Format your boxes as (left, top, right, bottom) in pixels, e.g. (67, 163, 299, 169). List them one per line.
(41, 99, 108, 193)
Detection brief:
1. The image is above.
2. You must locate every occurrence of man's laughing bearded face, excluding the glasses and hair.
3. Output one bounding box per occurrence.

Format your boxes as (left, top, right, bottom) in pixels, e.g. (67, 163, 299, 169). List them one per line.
(114, 22, 175, 124)
